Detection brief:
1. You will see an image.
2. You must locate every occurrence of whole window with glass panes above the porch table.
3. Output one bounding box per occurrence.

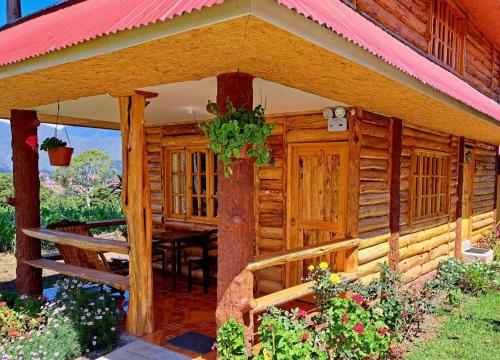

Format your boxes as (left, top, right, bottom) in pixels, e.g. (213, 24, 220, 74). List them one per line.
(165, 147, 218, 222)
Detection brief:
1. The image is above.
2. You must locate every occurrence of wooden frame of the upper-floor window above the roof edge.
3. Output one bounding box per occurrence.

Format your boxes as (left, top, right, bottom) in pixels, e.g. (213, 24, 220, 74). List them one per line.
(427, 0, 467, 75)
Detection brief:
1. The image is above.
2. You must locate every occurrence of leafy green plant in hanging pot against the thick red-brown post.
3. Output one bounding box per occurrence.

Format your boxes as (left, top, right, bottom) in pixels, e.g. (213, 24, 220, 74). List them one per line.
(199, 101, 275, 176)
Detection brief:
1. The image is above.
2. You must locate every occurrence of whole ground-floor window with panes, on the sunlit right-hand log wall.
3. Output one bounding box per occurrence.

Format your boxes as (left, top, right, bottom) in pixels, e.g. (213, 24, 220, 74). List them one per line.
(409, 149, 450, 223)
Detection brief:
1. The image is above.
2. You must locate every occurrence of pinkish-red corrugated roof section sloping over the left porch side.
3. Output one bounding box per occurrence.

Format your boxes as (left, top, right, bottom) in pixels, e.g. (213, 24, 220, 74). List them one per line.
(0, 0, 224, 66)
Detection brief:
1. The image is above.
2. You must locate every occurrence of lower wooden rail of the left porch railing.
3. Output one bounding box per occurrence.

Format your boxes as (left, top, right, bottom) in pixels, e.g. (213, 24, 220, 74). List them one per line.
(24, 259, 129, 291)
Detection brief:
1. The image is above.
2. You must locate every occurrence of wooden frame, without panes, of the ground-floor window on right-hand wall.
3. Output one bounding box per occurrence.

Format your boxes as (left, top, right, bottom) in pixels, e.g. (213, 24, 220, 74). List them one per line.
(408, 147, 451, 225)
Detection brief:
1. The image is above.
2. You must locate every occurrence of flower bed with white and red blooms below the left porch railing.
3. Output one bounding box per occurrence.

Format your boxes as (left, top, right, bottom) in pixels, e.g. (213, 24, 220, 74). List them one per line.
(0, 278, 121, 360)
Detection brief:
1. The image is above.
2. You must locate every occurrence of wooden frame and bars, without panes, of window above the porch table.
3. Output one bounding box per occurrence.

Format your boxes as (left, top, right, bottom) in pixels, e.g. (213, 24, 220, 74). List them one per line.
(163, 145, 218, 225)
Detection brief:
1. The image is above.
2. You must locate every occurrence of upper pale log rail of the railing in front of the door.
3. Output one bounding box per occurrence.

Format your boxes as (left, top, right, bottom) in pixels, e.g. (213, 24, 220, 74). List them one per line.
(246, 239, 360, 271)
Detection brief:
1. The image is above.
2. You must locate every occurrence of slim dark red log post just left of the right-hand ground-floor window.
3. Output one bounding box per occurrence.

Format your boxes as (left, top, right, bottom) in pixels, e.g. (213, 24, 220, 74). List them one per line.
(389, 118, 403, 271)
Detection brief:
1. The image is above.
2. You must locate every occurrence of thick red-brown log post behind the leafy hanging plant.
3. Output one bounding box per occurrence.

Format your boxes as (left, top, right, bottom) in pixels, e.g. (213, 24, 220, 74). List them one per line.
(216, 72, 255, 345)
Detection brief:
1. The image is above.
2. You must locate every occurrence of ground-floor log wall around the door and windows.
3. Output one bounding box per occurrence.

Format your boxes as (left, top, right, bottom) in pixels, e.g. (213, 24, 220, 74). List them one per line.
(146, 111, 495, 293)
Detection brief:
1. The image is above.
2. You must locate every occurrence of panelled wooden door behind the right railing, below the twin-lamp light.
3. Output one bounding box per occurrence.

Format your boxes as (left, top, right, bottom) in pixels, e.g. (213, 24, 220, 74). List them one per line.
(286, 142, 348, 286)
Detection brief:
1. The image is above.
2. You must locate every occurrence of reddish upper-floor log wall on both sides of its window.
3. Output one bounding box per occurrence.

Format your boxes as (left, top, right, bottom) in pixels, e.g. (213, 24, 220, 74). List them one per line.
(344, 0, 500, 102)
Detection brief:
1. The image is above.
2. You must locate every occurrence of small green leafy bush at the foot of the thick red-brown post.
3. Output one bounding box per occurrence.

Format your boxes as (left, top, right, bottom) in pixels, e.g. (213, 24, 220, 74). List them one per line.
(216, 319, 247, 360)
